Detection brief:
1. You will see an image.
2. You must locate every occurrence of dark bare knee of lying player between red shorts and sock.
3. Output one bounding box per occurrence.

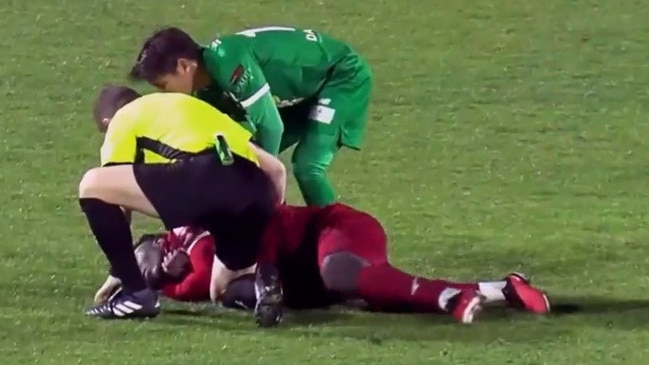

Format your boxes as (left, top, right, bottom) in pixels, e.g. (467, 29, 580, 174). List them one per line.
(320, 252, 370, 294)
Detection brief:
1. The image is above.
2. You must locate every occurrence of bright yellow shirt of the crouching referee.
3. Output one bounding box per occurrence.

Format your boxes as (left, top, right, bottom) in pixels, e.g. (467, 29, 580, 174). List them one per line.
(101, 93, 259, 166)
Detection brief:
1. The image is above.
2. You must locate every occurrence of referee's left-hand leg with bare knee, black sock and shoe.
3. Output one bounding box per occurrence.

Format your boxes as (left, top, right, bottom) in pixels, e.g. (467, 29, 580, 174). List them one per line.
(79, 165, 160, 319)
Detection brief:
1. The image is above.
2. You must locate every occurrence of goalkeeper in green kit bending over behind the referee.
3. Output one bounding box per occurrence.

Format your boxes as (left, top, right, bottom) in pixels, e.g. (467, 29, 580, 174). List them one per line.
(130, 26, 372, 205)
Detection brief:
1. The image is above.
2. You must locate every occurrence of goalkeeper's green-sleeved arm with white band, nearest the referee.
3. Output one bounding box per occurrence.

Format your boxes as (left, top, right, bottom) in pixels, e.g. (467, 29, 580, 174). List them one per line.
(203, 44, 284, 156)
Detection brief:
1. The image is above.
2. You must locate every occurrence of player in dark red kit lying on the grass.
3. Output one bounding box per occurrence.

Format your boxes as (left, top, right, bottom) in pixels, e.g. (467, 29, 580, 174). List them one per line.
(97, 204, 550, 323)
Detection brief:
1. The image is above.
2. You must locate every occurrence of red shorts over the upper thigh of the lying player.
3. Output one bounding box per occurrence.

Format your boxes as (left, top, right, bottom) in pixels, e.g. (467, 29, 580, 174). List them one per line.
(318, 204, 388, 266)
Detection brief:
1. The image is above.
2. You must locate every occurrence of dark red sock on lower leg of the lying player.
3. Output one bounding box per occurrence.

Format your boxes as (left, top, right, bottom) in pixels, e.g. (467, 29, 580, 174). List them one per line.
(358, 264, 478, 313)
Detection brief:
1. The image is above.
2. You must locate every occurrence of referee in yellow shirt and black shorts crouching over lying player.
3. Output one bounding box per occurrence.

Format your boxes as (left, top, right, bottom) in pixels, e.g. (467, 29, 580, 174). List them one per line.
(79, 86, 286, 319)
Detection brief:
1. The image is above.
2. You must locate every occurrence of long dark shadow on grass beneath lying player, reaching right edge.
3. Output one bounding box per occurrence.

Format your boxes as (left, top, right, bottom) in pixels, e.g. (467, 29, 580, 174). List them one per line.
(158, 297, 649, 345)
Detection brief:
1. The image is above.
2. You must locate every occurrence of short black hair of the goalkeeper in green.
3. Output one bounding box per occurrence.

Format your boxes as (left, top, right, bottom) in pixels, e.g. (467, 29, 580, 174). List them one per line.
(128, 27, 203, 82)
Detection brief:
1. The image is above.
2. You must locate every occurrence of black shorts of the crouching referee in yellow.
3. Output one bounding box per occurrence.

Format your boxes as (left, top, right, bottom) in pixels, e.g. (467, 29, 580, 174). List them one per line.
(133, 153, 276, 270)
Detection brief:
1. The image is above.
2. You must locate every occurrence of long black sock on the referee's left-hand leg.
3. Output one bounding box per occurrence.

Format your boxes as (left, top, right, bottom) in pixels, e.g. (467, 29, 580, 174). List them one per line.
(79, 198, 146, 292)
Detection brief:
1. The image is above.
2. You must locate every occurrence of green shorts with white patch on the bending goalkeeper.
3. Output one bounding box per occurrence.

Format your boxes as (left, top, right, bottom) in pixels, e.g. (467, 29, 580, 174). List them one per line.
(280, 54, 372, 151)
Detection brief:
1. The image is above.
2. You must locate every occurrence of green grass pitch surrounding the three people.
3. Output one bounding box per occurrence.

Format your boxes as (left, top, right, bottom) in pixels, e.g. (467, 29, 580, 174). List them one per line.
(0, 0, 649, 365)
